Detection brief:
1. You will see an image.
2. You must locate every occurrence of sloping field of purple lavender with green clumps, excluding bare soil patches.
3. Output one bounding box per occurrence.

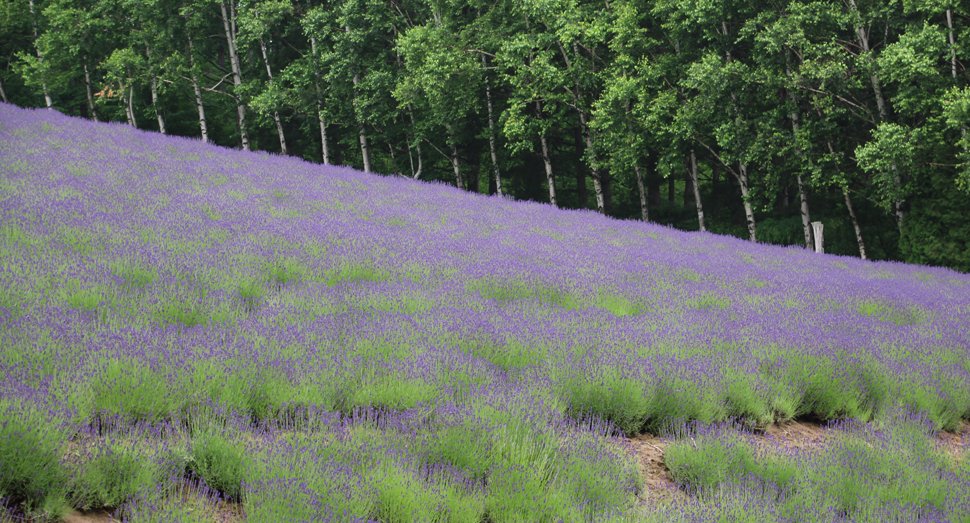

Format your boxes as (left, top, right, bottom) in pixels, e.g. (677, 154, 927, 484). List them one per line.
(0, 104, 970, 523)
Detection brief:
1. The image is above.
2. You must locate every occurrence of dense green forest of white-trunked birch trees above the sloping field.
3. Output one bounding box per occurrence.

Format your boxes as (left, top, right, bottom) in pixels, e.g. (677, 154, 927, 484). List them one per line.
(0, 0, 970, 271)
